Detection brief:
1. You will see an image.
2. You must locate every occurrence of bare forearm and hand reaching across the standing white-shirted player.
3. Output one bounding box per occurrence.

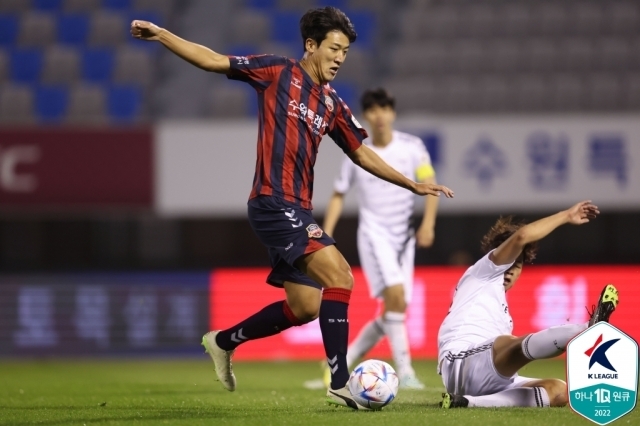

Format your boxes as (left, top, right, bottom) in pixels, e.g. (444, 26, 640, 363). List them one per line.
(347, 145, 453, 198)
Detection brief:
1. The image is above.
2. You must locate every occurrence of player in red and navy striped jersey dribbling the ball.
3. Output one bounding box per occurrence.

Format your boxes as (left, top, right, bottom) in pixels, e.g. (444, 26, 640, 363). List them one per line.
(131, 7, 453, 409)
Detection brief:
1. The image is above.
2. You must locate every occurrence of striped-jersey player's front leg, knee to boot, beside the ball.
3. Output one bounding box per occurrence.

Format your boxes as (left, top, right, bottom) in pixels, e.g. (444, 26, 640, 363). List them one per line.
(296, 245, 365, 410)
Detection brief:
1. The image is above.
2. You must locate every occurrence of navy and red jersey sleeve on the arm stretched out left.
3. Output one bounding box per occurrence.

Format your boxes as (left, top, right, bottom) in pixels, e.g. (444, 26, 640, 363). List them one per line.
(227, 55, 288, 90)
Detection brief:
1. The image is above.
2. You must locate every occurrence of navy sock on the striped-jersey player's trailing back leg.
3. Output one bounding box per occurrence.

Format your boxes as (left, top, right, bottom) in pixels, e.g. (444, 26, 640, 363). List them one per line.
(216, 300, 302, 351)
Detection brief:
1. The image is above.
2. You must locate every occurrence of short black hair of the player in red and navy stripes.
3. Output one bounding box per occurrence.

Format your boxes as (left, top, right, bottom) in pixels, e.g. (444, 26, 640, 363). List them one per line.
(300, 6, 358, 50)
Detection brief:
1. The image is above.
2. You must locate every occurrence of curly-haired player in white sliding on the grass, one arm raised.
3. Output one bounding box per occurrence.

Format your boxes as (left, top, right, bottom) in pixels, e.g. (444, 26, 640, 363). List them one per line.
(438, 201, 618, 408)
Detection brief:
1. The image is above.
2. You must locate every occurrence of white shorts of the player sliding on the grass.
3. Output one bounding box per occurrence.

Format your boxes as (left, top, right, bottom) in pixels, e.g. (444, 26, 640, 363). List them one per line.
(440, 339, 538, 396)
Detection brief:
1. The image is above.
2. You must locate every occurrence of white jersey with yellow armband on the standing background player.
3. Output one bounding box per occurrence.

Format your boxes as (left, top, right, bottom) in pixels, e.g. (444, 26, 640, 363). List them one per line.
(334, 130, 434, 248)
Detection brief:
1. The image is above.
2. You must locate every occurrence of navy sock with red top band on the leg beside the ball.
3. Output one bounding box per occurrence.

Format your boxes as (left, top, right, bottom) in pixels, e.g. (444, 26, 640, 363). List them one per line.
(320, 288, 351, 389)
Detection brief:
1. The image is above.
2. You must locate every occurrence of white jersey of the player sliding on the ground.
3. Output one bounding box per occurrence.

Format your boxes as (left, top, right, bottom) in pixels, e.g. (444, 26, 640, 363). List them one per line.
(438, 253, 513, 364)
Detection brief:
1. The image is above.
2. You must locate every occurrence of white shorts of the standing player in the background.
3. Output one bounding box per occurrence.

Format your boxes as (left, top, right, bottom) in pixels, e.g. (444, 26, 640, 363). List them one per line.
(358, 230, 416, 304)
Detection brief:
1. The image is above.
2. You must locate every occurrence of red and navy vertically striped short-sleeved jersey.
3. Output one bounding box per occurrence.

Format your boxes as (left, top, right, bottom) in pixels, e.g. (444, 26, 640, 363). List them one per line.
(227, 55, 367, 209)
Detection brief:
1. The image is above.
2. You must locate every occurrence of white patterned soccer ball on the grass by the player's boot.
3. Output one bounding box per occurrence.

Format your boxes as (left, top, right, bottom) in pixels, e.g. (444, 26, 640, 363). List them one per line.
(347, 359, 399, 410)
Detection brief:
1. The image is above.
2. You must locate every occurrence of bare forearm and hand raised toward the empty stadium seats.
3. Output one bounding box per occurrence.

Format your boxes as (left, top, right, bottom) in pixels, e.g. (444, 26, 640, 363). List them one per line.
(131, 20, 230, 74)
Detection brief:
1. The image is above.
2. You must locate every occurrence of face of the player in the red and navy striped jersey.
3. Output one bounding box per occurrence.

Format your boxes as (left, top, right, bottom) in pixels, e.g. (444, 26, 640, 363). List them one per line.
(307, 30, 349, 83)
